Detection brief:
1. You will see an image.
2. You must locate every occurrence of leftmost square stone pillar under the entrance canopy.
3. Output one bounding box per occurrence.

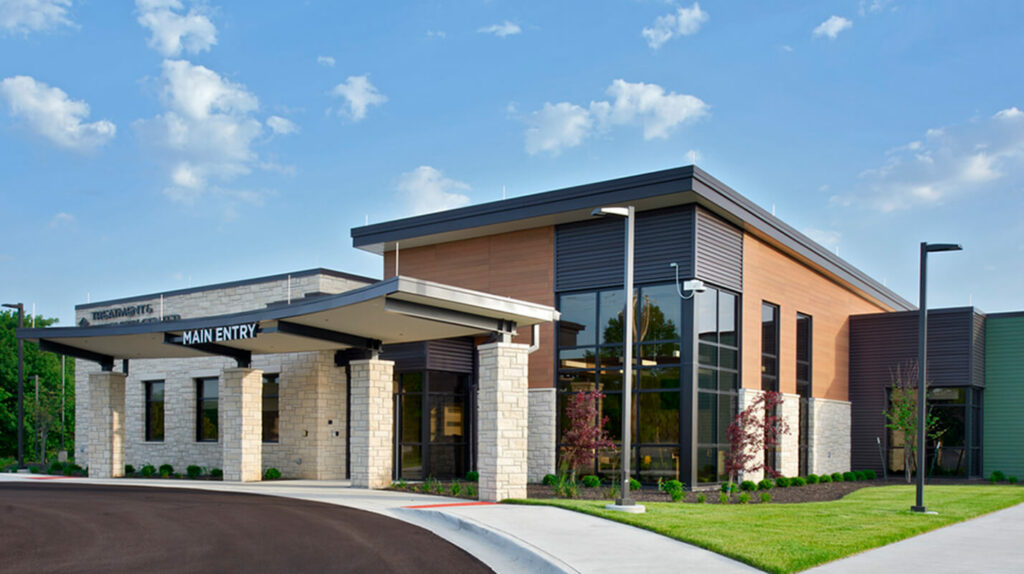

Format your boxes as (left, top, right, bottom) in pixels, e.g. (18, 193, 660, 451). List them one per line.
(87, 370, 127, 478)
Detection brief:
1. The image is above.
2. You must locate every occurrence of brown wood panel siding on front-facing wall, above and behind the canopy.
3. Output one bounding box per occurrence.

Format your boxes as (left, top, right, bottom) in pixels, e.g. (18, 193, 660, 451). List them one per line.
(384, 227, 555, 388)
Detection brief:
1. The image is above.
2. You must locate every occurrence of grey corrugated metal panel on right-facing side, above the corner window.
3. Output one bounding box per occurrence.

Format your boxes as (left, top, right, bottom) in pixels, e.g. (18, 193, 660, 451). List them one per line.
(694, 209, 743, 292)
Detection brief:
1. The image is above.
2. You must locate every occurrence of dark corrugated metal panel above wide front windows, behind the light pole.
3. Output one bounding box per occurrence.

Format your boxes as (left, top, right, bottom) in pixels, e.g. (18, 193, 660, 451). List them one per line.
(555, 206, 694, 292)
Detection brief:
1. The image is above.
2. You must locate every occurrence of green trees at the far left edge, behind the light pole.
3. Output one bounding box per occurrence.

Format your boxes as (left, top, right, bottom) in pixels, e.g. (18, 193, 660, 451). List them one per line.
(0, 310, 75, 460)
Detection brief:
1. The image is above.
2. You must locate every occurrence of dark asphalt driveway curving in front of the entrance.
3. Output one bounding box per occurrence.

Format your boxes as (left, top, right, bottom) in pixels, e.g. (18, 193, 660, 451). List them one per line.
(0, 480, 490, 573)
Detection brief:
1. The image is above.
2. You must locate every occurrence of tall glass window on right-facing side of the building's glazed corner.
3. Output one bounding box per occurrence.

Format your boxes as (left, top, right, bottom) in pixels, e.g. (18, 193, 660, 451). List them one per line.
(695, 289, 739, 482)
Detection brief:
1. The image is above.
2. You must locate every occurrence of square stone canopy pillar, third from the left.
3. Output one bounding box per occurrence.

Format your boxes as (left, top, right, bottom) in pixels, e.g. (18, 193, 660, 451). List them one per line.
(348, 359, 394, 488)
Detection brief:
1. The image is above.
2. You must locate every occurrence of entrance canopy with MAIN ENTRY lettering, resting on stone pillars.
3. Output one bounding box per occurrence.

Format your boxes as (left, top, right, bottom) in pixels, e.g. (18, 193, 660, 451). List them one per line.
(17, 276, 558, 370)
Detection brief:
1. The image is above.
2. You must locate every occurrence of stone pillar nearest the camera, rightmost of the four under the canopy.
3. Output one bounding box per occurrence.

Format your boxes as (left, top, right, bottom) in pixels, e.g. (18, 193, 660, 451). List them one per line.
(476, 343, 529, 501)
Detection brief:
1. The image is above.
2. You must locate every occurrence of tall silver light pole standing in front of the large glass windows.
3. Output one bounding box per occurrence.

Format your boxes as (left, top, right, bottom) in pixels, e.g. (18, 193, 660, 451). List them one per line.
(591, 206, 644, 513)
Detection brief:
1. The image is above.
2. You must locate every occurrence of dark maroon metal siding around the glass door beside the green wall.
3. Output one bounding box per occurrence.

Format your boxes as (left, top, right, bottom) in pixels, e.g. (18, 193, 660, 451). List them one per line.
(850, 308, 984, 474)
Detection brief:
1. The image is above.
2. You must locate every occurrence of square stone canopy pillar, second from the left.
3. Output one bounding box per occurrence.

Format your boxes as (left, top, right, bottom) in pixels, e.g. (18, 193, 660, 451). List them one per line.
(218, 368, 263, 482)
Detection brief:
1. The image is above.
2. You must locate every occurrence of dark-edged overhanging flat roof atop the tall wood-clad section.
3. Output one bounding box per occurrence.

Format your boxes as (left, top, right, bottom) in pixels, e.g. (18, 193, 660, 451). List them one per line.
(351, 166, 916, 310)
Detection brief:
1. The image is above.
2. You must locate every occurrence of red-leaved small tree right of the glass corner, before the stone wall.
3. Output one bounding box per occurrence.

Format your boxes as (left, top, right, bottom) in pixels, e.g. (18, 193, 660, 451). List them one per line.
(725, 391, 790, 483)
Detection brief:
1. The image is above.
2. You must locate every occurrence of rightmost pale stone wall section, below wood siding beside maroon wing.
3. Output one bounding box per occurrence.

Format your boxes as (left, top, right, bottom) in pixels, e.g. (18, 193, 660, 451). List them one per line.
(807, 398, 851, 475)
